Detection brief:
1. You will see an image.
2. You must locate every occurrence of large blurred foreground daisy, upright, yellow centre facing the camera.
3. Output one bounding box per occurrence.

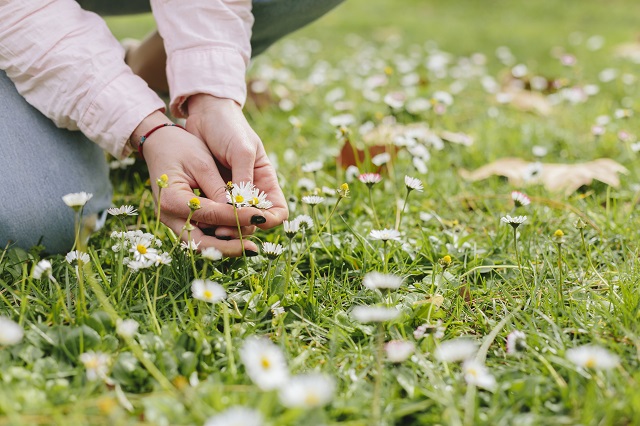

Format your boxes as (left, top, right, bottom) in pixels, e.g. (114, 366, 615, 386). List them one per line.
(240, 336, 289, 391)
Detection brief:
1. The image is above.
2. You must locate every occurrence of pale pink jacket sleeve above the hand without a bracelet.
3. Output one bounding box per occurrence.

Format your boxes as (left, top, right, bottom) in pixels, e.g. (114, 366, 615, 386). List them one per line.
(151, 0, 253, 117)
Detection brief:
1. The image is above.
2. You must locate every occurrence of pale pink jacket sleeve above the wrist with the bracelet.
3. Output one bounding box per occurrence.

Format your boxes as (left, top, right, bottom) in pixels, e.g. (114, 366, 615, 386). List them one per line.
(0, 0, 164, 157)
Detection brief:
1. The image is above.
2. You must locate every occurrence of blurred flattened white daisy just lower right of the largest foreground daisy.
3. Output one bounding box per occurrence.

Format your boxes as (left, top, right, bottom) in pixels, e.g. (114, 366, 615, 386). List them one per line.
(279, 373, 336, 408)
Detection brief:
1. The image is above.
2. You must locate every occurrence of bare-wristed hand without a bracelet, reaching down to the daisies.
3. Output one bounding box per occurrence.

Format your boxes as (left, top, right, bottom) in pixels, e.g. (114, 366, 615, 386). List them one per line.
(186, 94, 289, 237)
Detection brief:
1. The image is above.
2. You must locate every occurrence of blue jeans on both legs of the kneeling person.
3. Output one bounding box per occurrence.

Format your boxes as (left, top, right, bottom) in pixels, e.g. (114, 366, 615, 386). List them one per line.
(0, 0, 342, 253)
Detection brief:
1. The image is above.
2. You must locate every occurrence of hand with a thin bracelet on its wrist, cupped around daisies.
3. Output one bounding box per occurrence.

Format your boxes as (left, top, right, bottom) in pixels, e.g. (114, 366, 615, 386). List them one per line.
(132, 111, 267, 256)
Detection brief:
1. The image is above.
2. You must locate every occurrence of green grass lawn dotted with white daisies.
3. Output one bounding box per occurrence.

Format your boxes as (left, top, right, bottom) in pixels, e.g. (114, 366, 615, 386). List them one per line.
(0, 0, 640, 426)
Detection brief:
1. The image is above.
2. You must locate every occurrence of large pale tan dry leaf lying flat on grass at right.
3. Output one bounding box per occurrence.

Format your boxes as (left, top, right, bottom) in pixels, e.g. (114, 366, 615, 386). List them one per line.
(459, 158, 628, 195)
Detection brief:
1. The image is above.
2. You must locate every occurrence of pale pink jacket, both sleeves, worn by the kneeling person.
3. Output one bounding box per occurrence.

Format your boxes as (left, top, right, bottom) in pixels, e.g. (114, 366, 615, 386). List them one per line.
(0, 0, 253, 158)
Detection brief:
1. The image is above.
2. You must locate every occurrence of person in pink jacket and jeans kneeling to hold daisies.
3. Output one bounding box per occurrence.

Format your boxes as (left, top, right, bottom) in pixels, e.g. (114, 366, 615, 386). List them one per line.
(0, 0, 341, 256)
